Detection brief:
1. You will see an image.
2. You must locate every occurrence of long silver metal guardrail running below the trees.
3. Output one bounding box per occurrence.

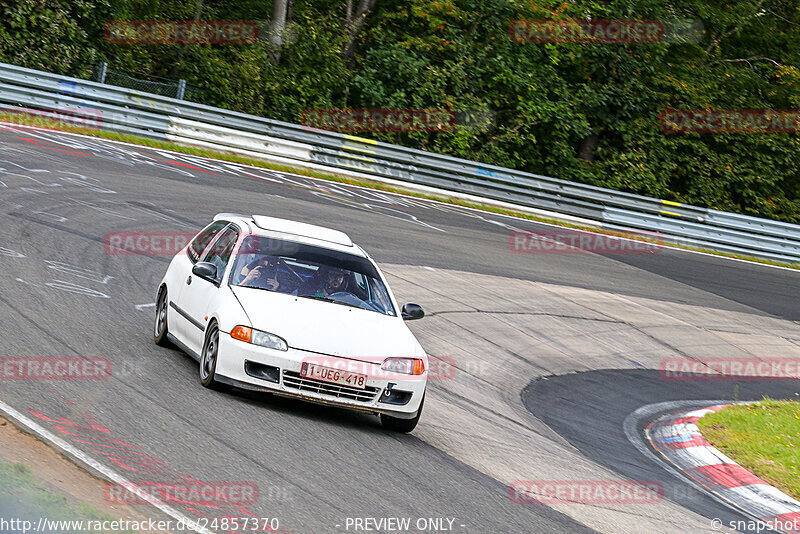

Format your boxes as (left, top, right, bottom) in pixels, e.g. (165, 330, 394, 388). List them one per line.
(0, 63, 800, 263)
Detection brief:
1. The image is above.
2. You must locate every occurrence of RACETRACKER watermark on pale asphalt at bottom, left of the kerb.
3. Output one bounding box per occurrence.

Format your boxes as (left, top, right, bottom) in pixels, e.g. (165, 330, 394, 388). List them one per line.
(508, 480, 664, 504)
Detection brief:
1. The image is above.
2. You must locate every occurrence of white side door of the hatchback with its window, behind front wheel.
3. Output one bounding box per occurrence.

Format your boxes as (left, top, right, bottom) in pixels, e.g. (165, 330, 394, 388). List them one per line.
(178, 224, 239, 354)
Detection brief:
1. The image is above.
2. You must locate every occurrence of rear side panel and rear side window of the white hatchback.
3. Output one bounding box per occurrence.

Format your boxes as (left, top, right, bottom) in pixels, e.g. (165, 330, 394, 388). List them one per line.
(167, 221, 230, 344)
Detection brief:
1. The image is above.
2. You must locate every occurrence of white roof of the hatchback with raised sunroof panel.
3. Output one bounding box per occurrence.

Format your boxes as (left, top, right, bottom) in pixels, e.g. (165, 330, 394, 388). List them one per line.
(209, 213, 367, 257)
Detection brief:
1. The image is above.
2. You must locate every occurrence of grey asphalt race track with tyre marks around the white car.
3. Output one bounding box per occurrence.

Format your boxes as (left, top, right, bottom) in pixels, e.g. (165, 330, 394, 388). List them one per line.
(0, 126, 800, 533)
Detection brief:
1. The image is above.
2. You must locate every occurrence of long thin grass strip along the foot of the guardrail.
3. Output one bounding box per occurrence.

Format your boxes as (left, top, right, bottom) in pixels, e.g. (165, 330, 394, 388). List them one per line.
(0, 112, 800, 270)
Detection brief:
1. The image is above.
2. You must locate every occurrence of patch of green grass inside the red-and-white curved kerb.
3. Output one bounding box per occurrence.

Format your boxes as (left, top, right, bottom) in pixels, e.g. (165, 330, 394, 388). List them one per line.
(697, 399, 800, 500)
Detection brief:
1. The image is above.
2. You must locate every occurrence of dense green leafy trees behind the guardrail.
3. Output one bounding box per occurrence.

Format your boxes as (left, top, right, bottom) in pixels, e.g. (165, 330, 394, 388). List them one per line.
(0, 0, 800, 222)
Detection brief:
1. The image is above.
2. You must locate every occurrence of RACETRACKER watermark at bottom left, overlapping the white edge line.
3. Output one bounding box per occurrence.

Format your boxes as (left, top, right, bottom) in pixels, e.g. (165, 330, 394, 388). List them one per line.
(103, 480, 258, 506)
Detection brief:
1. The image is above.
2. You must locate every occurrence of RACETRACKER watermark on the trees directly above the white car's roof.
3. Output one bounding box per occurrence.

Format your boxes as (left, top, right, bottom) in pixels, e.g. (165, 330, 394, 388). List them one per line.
(300, 109, 456, 132)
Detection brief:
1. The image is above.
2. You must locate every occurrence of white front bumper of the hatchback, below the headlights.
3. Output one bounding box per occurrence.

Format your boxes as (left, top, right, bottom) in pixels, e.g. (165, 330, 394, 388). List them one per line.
(211, 333, 427, 419)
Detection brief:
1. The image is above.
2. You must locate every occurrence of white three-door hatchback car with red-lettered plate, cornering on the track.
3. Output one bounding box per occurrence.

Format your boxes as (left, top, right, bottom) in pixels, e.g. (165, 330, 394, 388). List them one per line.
(154, 214, 428, 432)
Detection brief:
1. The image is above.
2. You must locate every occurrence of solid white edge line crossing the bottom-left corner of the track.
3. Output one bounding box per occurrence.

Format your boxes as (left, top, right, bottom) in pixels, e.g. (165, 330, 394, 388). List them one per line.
(0, 400, 214, 534)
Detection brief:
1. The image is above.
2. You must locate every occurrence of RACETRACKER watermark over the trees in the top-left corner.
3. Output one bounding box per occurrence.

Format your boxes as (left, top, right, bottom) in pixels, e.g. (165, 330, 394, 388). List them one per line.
(103, 20, 259, 45)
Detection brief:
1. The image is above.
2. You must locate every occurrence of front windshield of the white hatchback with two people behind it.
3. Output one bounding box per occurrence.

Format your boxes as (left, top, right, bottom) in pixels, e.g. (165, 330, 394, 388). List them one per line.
(230, 236, 396, 316)
